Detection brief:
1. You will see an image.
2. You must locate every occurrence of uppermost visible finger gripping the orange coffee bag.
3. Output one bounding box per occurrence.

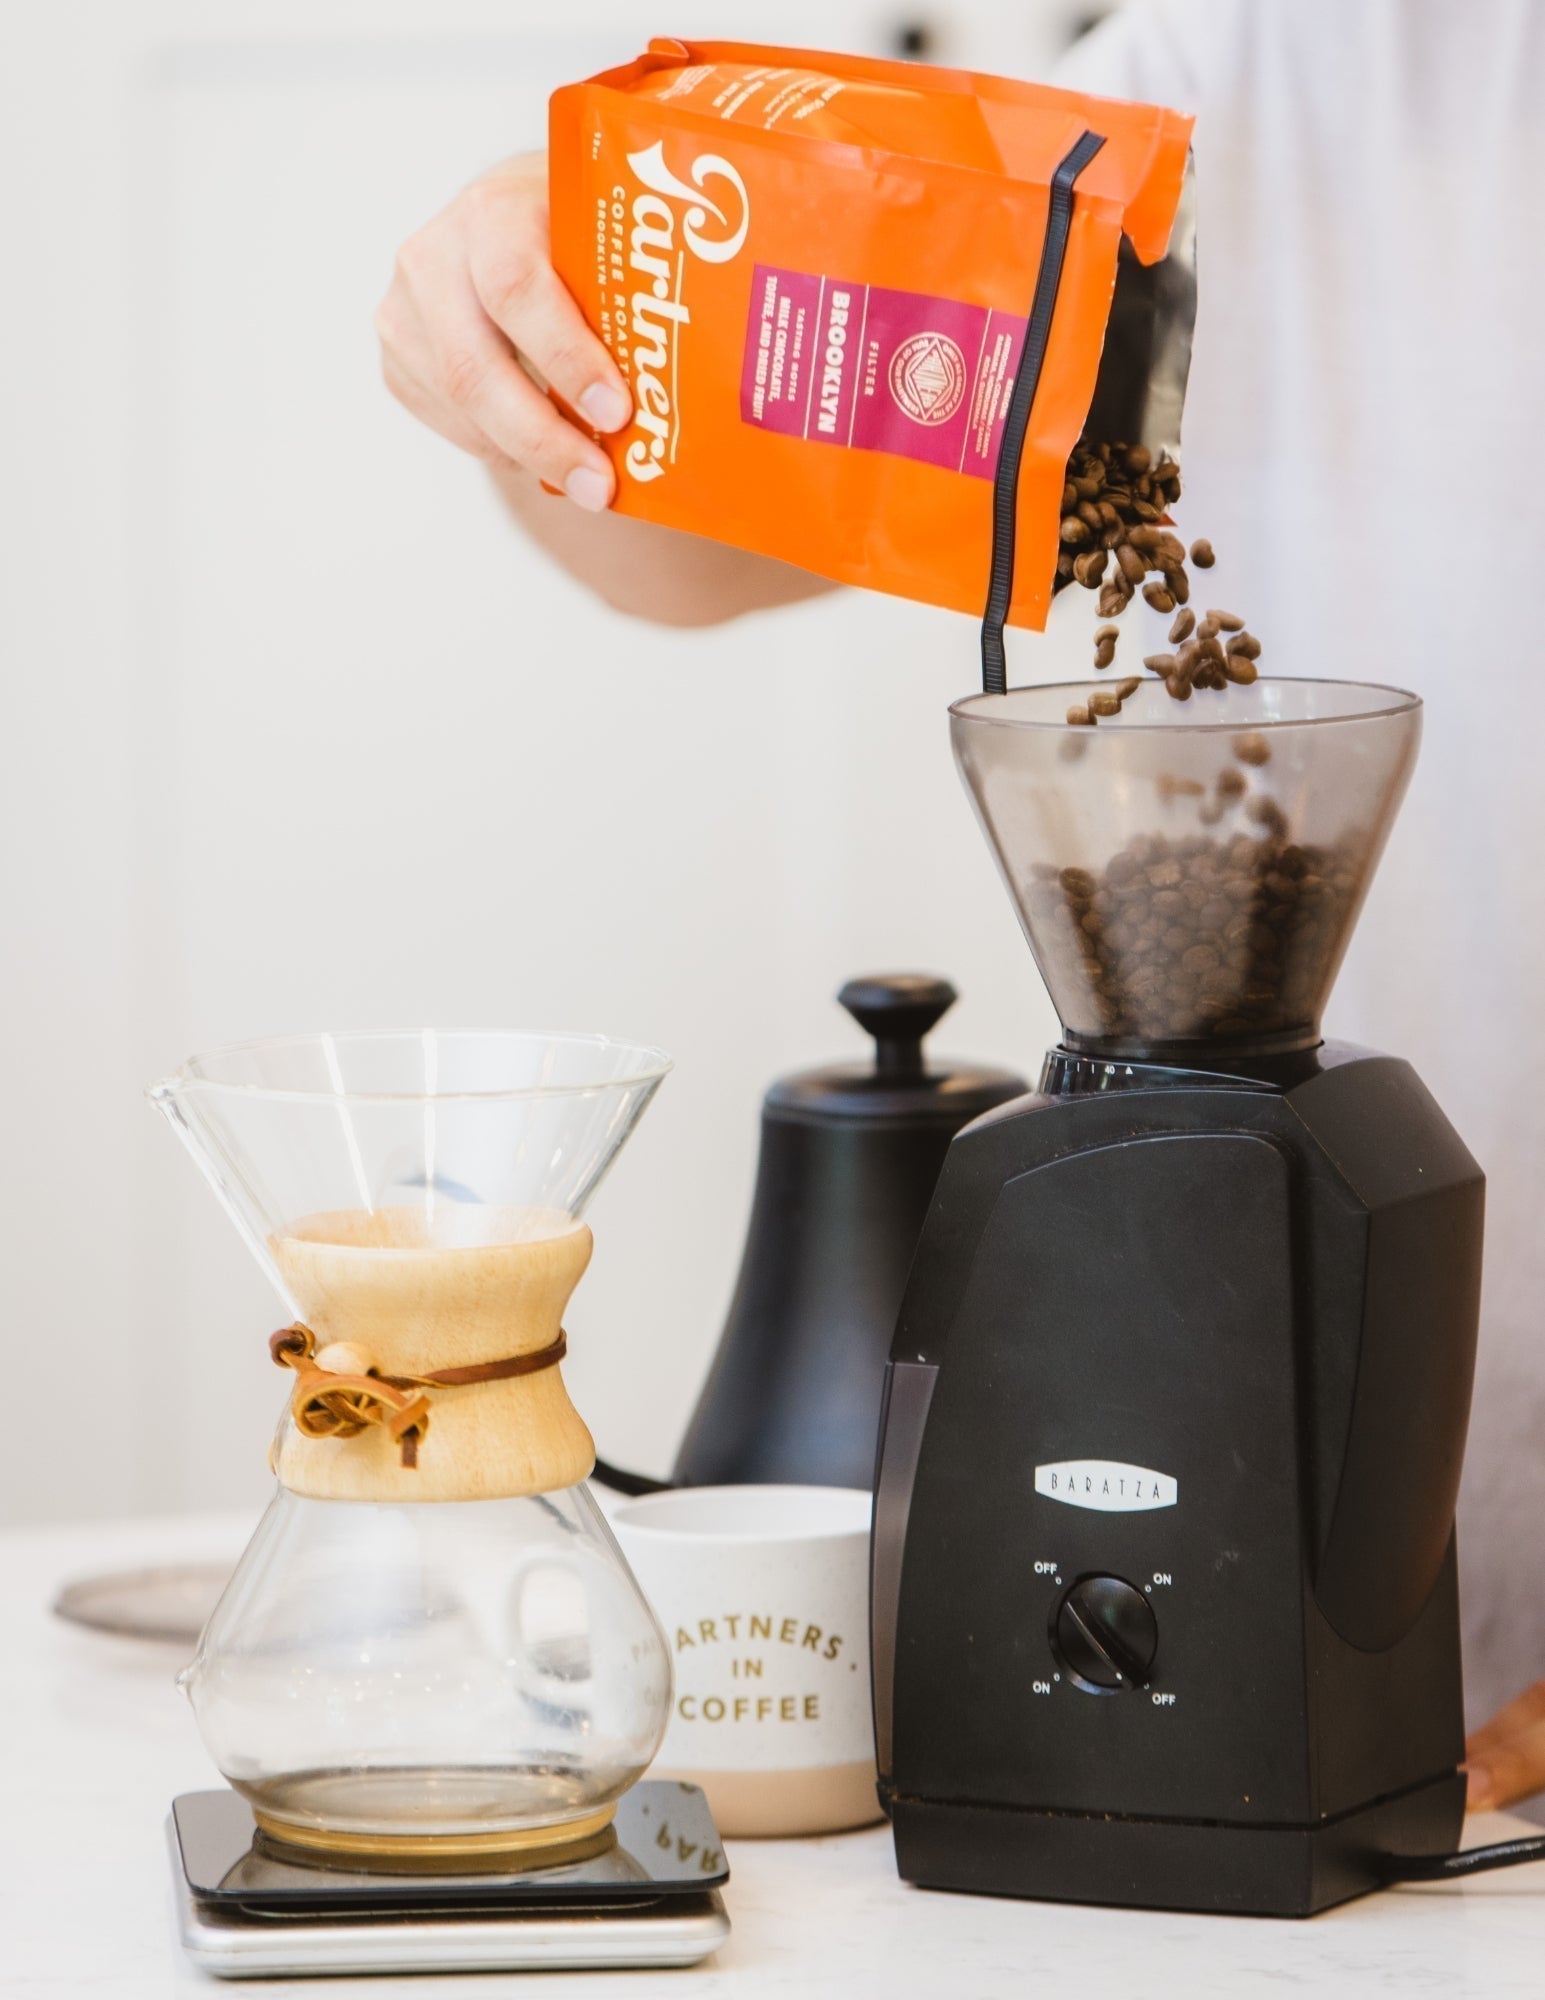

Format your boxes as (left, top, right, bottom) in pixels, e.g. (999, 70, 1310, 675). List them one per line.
(464, 174, 632, 430)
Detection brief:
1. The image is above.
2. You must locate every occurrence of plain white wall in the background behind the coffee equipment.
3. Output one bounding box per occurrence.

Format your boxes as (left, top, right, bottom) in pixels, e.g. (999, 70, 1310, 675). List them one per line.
(0, 0, 1083, 1520)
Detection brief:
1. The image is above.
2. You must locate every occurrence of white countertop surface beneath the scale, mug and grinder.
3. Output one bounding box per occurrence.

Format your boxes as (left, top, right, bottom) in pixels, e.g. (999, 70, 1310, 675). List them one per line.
(0, 1518, 1545, 2000)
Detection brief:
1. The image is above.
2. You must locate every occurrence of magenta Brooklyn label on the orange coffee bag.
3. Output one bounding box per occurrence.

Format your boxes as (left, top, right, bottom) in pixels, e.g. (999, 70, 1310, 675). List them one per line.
(740, 264, 1025, 480)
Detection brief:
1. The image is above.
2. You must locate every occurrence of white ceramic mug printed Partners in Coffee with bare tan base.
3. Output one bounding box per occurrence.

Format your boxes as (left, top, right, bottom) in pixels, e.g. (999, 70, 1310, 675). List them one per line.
(612, 1486, 881, 1836)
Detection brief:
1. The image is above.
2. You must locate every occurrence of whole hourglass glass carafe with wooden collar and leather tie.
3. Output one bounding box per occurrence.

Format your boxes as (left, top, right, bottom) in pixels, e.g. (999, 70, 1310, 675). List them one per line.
(150, 1032, 670, 1866)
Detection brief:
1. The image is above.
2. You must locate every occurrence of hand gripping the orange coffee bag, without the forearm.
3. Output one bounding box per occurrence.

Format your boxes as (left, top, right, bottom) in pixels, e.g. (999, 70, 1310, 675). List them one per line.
(376, 152, 632, 512)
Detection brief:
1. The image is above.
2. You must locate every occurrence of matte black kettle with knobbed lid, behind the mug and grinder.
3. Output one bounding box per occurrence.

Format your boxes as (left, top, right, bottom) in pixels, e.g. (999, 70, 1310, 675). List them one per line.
(672, 972, 1029, 1486)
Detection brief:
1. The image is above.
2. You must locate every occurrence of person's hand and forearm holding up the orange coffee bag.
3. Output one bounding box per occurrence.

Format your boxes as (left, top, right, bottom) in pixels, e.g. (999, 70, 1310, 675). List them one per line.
(376, 152, 833, 624)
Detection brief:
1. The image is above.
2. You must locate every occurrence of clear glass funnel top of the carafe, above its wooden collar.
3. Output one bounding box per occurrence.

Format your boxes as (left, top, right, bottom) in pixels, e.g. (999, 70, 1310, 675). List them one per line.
(150, 1030, 670, 1296)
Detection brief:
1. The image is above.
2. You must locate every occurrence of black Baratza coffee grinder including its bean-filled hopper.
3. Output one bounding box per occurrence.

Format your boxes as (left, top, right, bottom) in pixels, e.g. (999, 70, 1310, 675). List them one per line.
(873, 680, 1483, 1916)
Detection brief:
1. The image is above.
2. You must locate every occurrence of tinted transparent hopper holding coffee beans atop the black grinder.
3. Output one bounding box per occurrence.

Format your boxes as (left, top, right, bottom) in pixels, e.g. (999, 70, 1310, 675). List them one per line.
(951, 680, 1421, 1058)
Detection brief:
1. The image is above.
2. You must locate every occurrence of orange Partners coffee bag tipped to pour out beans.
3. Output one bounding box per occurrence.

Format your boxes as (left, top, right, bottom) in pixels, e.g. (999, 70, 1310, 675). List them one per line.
(550, 42, 1195, 628)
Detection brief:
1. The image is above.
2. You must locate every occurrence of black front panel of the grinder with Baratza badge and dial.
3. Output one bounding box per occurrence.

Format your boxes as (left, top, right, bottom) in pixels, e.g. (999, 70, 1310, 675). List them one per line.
(893, 1132, 1311, 1824)
